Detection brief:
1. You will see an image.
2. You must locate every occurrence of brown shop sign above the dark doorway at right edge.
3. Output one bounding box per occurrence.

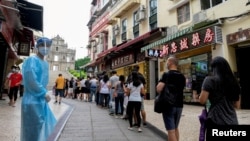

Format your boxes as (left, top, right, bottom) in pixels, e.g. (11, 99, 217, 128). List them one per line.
(226, 28, 250, 45)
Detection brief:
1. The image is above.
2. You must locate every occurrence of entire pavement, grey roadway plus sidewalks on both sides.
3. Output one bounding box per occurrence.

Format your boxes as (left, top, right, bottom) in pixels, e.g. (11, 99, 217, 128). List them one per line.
(0, 91, 250, 141)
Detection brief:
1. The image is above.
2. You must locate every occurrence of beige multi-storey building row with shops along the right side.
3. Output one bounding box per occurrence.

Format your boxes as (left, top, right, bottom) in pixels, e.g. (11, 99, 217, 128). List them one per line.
(87, 0, 250, 109)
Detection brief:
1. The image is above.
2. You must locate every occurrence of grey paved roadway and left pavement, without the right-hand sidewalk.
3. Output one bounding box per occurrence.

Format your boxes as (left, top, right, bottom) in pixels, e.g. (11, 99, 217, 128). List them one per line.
(0, 91, 164, 141)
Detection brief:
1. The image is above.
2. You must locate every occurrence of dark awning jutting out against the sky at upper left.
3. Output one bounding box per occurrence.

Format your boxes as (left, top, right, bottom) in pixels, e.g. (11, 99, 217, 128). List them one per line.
(16, 0, 43, 31)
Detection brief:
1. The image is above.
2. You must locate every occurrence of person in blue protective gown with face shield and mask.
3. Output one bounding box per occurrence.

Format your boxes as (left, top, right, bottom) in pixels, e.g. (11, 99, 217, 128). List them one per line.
(21, 37, 57, 141)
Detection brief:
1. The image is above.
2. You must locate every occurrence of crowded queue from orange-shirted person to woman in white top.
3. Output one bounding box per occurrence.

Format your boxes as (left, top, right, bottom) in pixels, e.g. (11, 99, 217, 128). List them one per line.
(50, 65, 147, 132)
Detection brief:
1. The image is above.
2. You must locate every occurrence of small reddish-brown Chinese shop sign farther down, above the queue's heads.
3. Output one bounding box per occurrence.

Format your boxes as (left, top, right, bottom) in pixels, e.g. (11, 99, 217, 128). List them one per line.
(111, 53, 134, 69)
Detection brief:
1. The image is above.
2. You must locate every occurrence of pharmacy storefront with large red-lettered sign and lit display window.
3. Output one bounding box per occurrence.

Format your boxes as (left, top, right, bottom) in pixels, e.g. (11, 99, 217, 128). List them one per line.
(146, 26, 222, 103)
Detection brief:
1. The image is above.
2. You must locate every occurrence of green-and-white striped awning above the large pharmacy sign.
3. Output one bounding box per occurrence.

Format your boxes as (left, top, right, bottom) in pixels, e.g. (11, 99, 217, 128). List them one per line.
(141, 27, 193, 52)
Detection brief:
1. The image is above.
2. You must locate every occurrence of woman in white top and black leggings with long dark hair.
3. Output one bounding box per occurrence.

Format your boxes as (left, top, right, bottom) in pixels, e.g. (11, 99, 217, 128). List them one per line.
(127, 72, 145, 132)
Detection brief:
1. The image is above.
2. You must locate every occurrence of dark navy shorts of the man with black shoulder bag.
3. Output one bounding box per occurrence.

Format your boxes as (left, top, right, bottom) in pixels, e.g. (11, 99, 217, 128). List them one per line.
(162, 107, 183, 130)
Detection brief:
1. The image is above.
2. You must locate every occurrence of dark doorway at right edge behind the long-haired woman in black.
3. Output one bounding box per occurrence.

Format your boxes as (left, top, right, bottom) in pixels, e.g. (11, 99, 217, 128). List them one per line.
(236, 46, 250, 109)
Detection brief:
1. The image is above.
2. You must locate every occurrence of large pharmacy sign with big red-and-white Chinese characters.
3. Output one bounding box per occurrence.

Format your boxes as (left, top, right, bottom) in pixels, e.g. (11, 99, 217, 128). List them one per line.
(146, 26, 222, 57)
